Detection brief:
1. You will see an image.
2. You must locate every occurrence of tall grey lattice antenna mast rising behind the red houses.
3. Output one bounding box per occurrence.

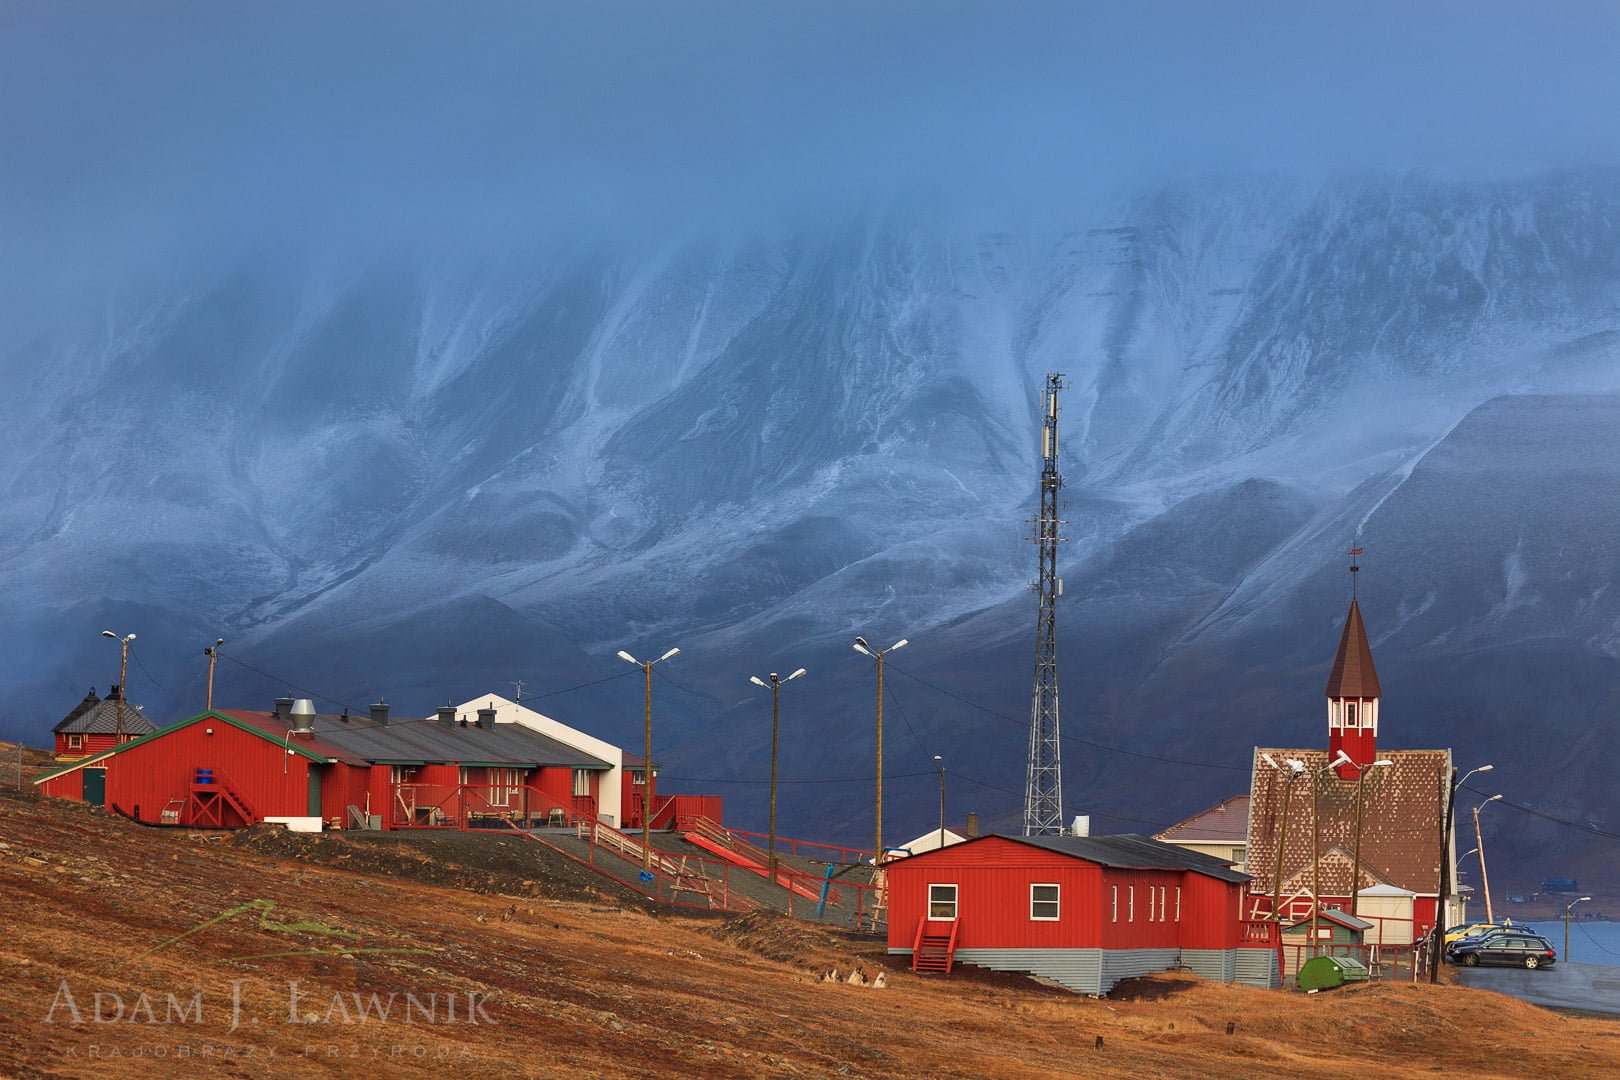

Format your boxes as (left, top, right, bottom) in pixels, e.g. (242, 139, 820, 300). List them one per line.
(1024, 372, 1064, 836)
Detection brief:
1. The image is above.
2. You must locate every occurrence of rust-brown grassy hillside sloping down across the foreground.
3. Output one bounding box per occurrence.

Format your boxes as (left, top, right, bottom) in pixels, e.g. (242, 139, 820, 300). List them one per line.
(0, 748, 1620, 1078)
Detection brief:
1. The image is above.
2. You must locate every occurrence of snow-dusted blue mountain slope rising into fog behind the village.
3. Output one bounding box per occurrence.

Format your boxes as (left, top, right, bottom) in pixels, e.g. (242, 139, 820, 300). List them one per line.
(0, 173, 1620, 867)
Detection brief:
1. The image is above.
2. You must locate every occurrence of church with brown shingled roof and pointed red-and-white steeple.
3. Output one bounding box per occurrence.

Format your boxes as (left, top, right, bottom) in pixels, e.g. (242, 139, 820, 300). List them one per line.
(1244, 563, 1461, 949)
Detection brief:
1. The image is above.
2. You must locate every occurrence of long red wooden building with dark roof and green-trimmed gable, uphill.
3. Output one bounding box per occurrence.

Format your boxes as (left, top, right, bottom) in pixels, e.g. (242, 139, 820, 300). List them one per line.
(34, 698, 622, 829)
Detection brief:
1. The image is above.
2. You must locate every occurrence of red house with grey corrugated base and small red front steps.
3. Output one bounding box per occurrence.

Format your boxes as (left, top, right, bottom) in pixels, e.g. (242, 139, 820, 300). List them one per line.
(886, 836, 1277, 994)
